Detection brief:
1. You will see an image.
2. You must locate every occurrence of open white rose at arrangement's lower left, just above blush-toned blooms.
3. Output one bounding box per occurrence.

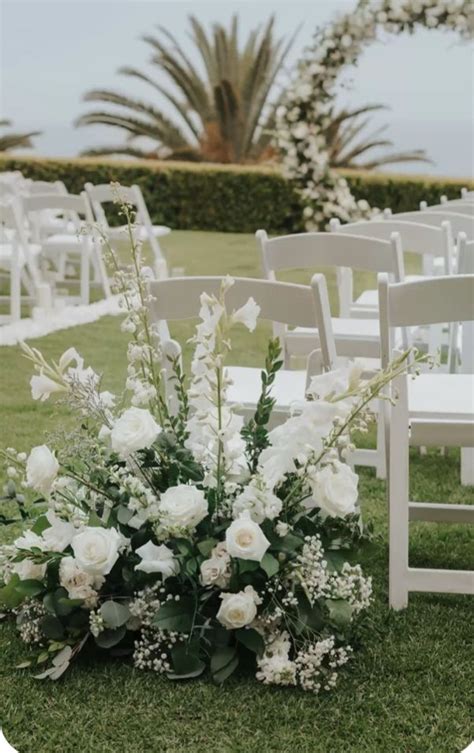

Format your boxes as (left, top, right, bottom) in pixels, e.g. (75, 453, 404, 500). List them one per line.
(71, 526, 125, 575)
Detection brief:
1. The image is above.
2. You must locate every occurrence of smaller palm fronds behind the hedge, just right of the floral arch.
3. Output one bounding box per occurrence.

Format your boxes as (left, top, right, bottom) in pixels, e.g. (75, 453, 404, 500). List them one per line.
(326, 104, 431, 170)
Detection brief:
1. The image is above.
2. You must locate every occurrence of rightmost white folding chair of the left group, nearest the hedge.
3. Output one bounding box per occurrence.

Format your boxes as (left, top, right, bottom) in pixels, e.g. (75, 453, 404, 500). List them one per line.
(85, 183, 171, 279)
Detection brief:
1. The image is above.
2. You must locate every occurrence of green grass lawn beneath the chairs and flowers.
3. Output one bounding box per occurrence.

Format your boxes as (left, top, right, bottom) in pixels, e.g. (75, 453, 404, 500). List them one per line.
(0, 232, 474, 753)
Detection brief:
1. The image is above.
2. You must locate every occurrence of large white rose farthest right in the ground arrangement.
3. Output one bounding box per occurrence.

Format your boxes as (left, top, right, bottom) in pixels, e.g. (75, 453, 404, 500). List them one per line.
(310, 460, 359, 518)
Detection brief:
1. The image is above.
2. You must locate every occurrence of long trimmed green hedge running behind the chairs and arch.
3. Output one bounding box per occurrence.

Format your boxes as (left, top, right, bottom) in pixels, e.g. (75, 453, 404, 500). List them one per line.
(0, 156, 474, 233)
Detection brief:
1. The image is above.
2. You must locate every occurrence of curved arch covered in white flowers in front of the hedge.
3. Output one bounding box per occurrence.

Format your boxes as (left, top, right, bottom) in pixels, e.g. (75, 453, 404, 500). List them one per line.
(275, 0, 474, 230)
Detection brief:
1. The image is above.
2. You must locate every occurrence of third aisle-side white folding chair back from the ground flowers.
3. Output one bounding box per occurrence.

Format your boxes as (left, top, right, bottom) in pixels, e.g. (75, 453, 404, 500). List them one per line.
(330, 215, 454, 317)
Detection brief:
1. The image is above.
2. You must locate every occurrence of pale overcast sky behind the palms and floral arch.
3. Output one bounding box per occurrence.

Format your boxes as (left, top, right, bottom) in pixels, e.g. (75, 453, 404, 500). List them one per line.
(0, 0, 474, 177)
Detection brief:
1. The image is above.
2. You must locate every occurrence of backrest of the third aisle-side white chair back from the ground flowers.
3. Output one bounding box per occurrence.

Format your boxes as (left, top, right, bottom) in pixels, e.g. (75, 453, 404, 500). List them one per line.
(330, 215, 453, 272)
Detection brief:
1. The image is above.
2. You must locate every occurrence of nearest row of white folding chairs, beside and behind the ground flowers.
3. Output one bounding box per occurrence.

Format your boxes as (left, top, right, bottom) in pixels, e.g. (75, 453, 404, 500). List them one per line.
(146, 274, 474, 609)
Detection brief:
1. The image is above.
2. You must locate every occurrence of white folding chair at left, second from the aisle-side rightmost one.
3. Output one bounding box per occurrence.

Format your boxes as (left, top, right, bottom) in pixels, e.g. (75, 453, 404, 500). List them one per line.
(23, 191, 110, 304)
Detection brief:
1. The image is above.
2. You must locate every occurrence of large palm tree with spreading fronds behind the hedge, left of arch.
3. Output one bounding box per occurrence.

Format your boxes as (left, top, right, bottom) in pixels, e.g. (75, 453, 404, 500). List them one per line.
(76, 16, 294, 162)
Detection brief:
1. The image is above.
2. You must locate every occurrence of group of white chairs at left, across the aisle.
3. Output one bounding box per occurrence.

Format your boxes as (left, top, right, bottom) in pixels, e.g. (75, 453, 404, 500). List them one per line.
(0, 173, 170, 322)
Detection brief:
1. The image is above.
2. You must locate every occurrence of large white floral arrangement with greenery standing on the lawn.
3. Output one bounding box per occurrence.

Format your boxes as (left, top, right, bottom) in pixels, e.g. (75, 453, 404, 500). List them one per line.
(0, 195, 422, 692)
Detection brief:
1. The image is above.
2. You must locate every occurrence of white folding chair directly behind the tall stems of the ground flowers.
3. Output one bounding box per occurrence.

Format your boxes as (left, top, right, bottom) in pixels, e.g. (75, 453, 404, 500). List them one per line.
(146, 275, 336, 425)
